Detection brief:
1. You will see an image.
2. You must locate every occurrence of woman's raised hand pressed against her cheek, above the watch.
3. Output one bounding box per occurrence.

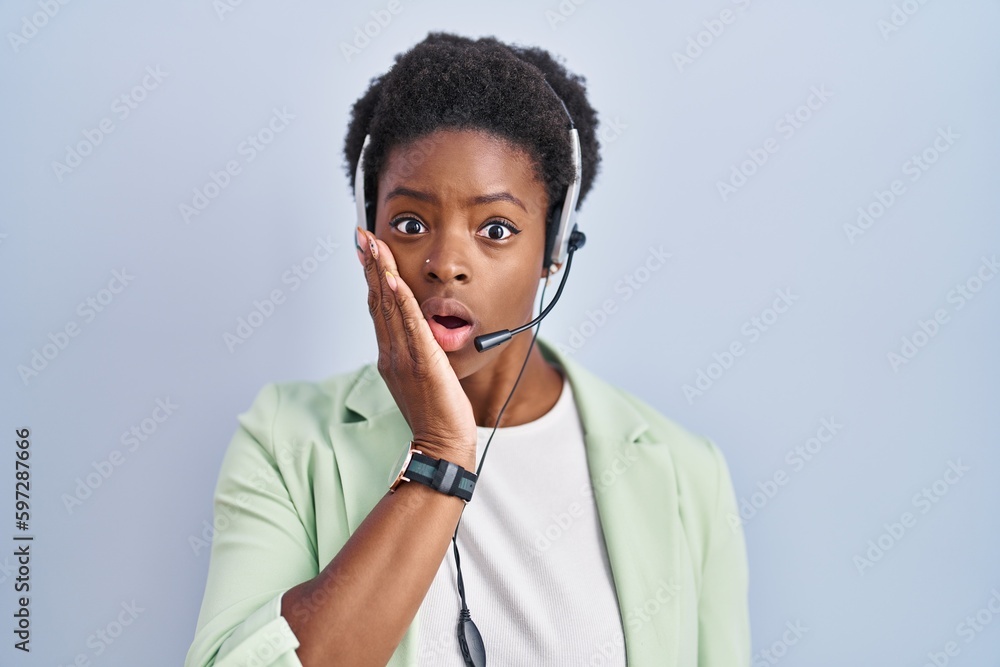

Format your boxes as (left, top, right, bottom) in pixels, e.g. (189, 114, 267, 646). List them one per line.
(357, 228, 478, 470)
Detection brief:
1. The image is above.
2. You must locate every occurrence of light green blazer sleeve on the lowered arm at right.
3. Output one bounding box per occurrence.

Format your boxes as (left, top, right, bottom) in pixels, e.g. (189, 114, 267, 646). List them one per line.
(698, 440, 750, 667)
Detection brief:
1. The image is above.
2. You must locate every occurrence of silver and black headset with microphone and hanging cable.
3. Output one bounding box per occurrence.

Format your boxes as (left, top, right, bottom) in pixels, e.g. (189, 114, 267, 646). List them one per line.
(354, 85, 587, 667)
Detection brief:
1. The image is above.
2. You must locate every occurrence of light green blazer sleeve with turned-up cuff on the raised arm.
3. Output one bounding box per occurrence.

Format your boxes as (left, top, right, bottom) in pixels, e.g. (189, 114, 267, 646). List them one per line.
(184, 385, 318, 667)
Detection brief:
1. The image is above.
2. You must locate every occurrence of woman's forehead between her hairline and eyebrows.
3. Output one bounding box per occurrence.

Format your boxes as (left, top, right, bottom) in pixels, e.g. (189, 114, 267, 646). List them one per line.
(378, 129, 547, 211)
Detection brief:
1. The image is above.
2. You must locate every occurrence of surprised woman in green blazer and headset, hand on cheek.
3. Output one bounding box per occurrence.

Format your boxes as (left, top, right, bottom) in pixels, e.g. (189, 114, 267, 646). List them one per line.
(187, 33, 750, 667)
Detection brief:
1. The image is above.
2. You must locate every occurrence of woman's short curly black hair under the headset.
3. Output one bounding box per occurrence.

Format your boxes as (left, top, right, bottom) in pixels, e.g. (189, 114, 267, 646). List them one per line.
(344, 32, 601, 263)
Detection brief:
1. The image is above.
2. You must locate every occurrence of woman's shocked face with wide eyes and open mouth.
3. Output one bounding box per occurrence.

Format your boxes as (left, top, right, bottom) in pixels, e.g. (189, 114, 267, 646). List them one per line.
(375, 130, 548, 379)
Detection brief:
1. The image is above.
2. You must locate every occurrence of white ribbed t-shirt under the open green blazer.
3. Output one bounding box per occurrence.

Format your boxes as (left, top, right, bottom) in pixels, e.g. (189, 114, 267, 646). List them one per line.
(418, 379, 625, 667)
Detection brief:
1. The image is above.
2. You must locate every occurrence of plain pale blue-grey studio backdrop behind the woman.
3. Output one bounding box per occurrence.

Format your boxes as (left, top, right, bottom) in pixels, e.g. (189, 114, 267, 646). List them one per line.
(0, 0, 1000, 667)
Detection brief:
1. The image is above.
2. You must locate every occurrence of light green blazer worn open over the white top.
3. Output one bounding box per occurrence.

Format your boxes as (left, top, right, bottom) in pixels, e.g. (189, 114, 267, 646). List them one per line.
(185, 338, 750, 667)
